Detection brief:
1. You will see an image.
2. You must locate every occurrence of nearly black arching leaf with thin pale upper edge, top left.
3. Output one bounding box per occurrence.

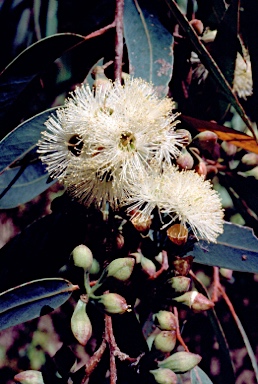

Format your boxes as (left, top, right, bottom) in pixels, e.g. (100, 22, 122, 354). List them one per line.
(0, 33, 85, 138)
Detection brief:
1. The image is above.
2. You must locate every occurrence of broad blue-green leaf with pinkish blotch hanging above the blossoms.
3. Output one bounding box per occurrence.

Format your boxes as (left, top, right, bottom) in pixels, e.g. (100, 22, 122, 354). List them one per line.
(124, 0, 173, 95)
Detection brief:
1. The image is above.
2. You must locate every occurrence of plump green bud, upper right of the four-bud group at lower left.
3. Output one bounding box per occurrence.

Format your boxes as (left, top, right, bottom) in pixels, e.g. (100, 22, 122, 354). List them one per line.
(107, 257, 135, 281)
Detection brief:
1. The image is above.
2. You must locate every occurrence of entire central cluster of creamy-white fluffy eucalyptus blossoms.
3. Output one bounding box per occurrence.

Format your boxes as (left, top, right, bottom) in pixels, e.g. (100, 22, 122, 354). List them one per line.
(38, 79, 223, 241)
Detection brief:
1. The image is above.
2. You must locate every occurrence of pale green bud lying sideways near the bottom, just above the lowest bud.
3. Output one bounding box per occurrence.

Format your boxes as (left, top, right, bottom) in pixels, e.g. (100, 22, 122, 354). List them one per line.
(158, 351, 202, 373)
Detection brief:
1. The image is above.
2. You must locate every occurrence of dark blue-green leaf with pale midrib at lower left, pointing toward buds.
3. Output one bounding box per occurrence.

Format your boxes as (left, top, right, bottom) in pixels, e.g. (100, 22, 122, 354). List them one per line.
(0, 278, 78, 330)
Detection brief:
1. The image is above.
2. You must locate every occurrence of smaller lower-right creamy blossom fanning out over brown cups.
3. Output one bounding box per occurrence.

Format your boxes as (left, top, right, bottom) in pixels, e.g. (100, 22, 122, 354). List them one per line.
(127, 166, 223, 242)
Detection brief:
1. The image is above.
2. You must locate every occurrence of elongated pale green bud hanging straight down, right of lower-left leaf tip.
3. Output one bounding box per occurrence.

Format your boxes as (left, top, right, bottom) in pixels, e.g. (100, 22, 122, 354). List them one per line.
(71, 299, 92, 345)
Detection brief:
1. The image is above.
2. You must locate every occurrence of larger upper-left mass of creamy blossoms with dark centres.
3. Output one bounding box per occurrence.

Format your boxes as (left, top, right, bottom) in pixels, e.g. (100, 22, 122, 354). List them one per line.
(38, 79, 184, 207)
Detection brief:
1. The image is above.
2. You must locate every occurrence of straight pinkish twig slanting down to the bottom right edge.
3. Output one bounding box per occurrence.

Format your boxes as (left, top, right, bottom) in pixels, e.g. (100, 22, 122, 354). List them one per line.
(218, 284, 258, 383)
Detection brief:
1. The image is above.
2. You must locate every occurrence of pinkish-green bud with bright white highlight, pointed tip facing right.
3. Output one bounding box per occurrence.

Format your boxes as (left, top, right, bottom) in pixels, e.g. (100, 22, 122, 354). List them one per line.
(173, 291, 214, 312)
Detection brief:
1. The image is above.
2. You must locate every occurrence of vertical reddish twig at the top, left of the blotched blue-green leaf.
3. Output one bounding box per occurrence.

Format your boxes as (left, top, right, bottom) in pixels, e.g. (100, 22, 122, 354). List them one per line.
(114, 0, 124, 82)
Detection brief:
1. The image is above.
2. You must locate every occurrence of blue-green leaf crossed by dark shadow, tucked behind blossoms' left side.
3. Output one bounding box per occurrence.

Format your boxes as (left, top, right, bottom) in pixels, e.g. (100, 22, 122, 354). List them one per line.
(0, 108, 55, 209)
